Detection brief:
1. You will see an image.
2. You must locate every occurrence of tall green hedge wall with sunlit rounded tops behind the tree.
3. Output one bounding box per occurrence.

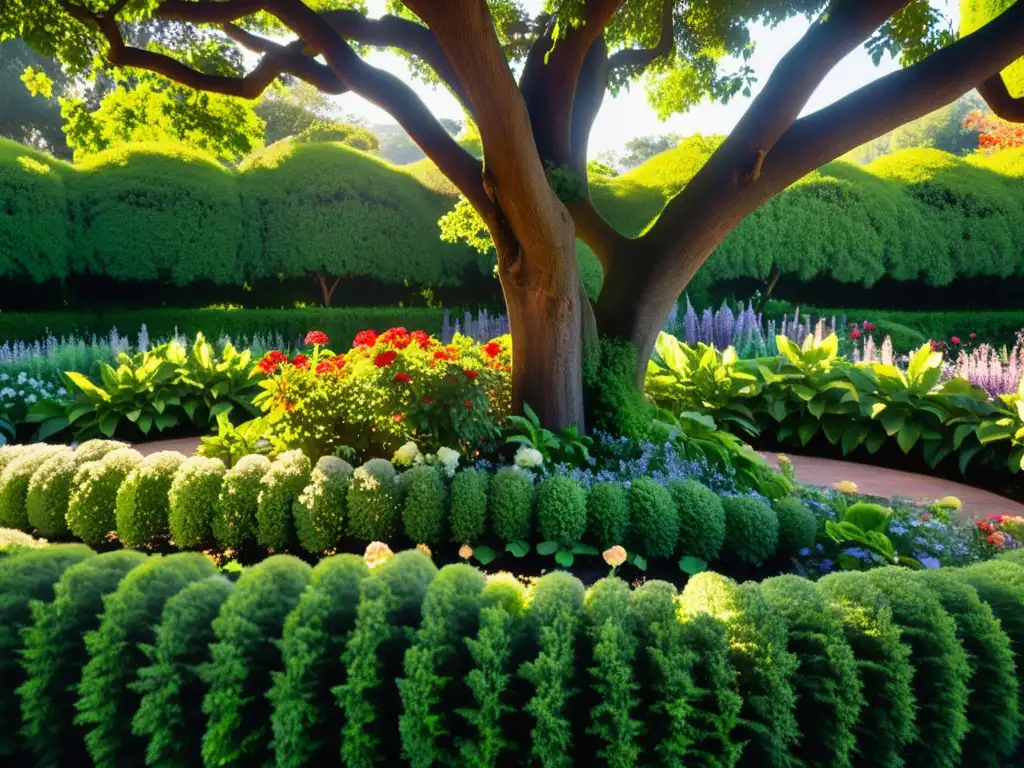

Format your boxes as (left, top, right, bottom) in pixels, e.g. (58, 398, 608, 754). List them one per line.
(0, 136, 1024, 303)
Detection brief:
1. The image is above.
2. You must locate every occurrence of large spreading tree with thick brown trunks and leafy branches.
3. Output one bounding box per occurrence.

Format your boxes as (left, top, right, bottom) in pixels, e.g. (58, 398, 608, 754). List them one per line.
(8, 0, 1024, 434)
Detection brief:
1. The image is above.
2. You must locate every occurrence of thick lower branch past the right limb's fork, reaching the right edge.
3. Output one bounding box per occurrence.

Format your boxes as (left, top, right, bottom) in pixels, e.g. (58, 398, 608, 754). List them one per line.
(761, 2, 1024, 190)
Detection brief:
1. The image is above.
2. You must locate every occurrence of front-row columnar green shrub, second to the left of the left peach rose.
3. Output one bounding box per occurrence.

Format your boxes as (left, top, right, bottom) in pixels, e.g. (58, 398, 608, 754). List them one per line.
(203, 555, 311, 765)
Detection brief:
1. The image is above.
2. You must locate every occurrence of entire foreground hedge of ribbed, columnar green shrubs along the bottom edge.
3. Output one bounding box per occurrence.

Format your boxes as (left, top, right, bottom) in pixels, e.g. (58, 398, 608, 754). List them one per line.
(6, 546, 1024, 768)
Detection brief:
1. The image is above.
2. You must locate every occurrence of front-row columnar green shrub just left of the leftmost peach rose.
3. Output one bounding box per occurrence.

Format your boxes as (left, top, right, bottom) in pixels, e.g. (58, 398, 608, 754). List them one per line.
(267, 555, 370, 768)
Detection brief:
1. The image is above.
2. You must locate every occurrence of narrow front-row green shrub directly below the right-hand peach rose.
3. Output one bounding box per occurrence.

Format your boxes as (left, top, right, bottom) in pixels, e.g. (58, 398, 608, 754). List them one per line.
(584, 577, 643, 767)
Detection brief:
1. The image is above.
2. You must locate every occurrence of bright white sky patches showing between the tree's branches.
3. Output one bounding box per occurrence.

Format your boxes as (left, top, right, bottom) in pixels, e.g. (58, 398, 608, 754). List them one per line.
(319, 0, 957, 157)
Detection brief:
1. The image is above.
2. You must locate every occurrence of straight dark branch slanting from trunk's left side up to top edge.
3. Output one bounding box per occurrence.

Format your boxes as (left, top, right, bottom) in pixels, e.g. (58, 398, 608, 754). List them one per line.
(265, 0, 494, 213)
